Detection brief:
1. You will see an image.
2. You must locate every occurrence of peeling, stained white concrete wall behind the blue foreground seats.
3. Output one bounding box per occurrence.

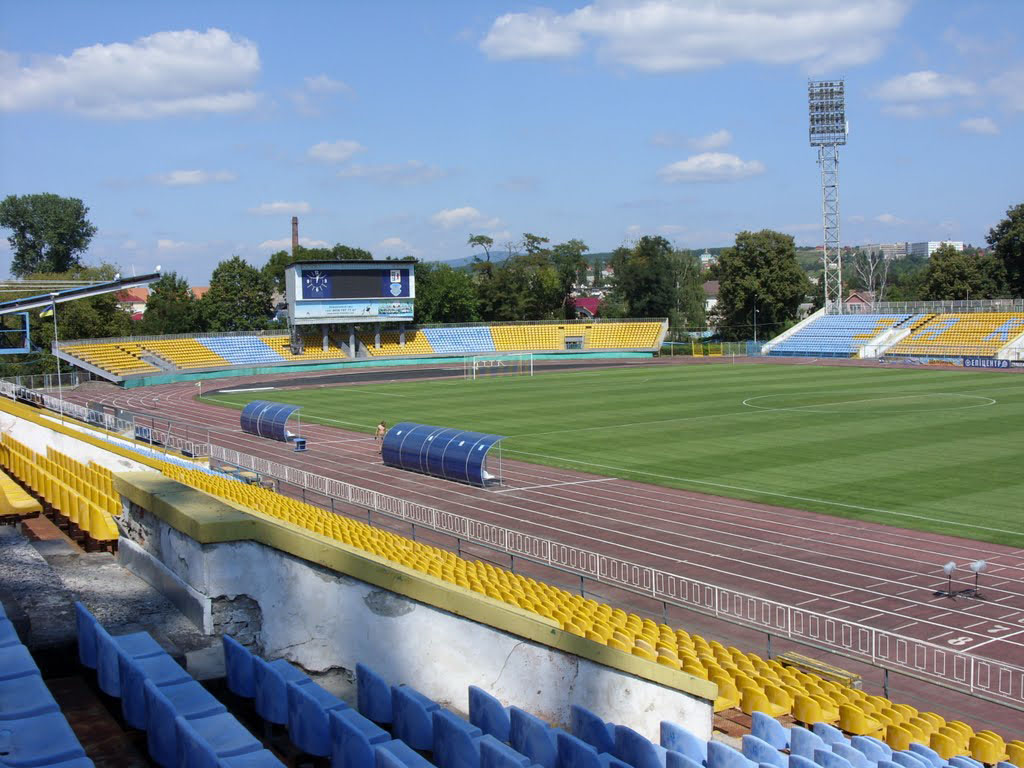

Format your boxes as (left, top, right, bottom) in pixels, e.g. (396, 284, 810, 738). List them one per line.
(119, 505, 712, 742)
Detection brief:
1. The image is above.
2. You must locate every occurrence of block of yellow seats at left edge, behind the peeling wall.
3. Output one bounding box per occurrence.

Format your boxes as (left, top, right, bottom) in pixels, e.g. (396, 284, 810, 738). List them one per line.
(0, 433, 121, 549)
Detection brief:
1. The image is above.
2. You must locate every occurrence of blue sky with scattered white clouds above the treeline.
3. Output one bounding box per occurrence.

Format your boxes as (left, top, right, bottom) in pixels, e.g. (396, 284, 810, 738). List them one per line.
(0, 0, 1024, 285)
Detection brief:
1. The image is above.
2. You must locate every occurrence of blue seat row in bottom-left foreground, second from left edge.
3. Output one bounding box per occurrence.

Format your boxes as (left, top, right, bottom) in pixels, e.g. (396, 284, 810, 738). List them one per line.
(75, 603, 284, 768)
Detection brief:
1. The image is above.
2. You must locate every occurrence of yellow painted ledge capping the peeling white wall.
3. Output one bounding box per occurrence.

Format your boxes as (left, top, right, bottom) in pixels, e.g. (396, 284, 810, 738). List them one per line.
(114, 472, 718, 701)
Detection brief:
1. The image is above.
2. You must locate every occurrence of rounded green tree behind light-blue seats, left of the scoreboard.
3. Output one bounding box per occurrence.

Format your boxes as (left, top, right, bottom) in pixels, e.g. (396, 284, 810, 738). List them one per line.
(200, 256, 272, 331)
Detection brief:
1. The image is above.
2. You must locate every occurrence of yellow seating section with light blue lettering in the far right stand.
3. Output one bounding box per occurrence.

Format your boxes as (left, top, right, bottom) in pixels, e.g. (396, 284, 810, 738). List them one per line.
(885, 312, 1024, 357)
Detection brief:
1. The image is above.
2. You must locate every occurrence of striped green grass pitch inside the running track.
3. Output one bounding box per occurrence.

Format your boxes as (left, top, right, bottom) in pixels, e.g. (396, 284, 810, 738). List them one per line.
(204, 364, 1024, 547)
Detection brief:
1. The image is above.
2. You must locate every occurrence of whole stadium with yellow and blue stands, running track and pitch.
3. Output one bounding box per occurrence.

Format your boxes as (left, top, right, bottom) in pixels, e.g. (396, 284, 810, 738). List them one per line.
(0, 257, 1024, 768)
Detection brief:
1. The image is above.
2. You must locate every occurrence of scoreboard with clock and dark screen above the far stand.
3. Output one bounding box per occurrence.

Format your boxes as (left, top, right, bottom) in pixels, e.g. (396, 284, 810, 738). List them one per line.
(285, 261, 416, 326)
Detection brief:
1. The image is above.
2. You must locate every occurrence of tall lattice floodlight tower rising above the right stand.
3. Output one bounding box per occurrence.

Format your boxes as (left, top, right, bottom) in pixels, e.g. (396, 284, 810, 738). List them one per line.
(807, 80, 848, 314)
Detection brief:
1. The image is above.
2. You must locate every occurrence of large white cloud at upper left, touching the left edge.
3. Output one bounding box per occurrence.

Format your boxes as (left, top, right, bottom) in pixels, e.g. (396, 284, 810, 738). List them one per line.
(0, 29, 262, 120)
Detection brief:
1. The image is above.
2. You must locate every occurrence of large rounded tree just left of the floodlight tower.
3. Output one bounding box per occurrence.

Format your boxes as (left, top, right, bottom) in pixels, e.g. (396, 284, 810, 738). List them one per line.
(715, 229, 810, 340)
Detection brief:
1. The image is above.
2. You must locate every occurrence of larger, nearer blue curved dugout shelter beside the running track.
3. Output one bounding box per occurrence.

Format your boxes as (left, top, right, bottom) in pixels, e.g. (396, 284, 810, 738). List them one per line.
(381, 421, 504, 487)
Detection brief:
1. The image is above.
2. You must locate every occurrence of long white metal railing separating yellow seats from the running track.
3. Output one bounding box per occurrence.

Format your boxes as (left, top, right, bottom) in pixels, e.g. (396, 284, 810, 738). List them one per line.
(8, 381, 1024, 711)
